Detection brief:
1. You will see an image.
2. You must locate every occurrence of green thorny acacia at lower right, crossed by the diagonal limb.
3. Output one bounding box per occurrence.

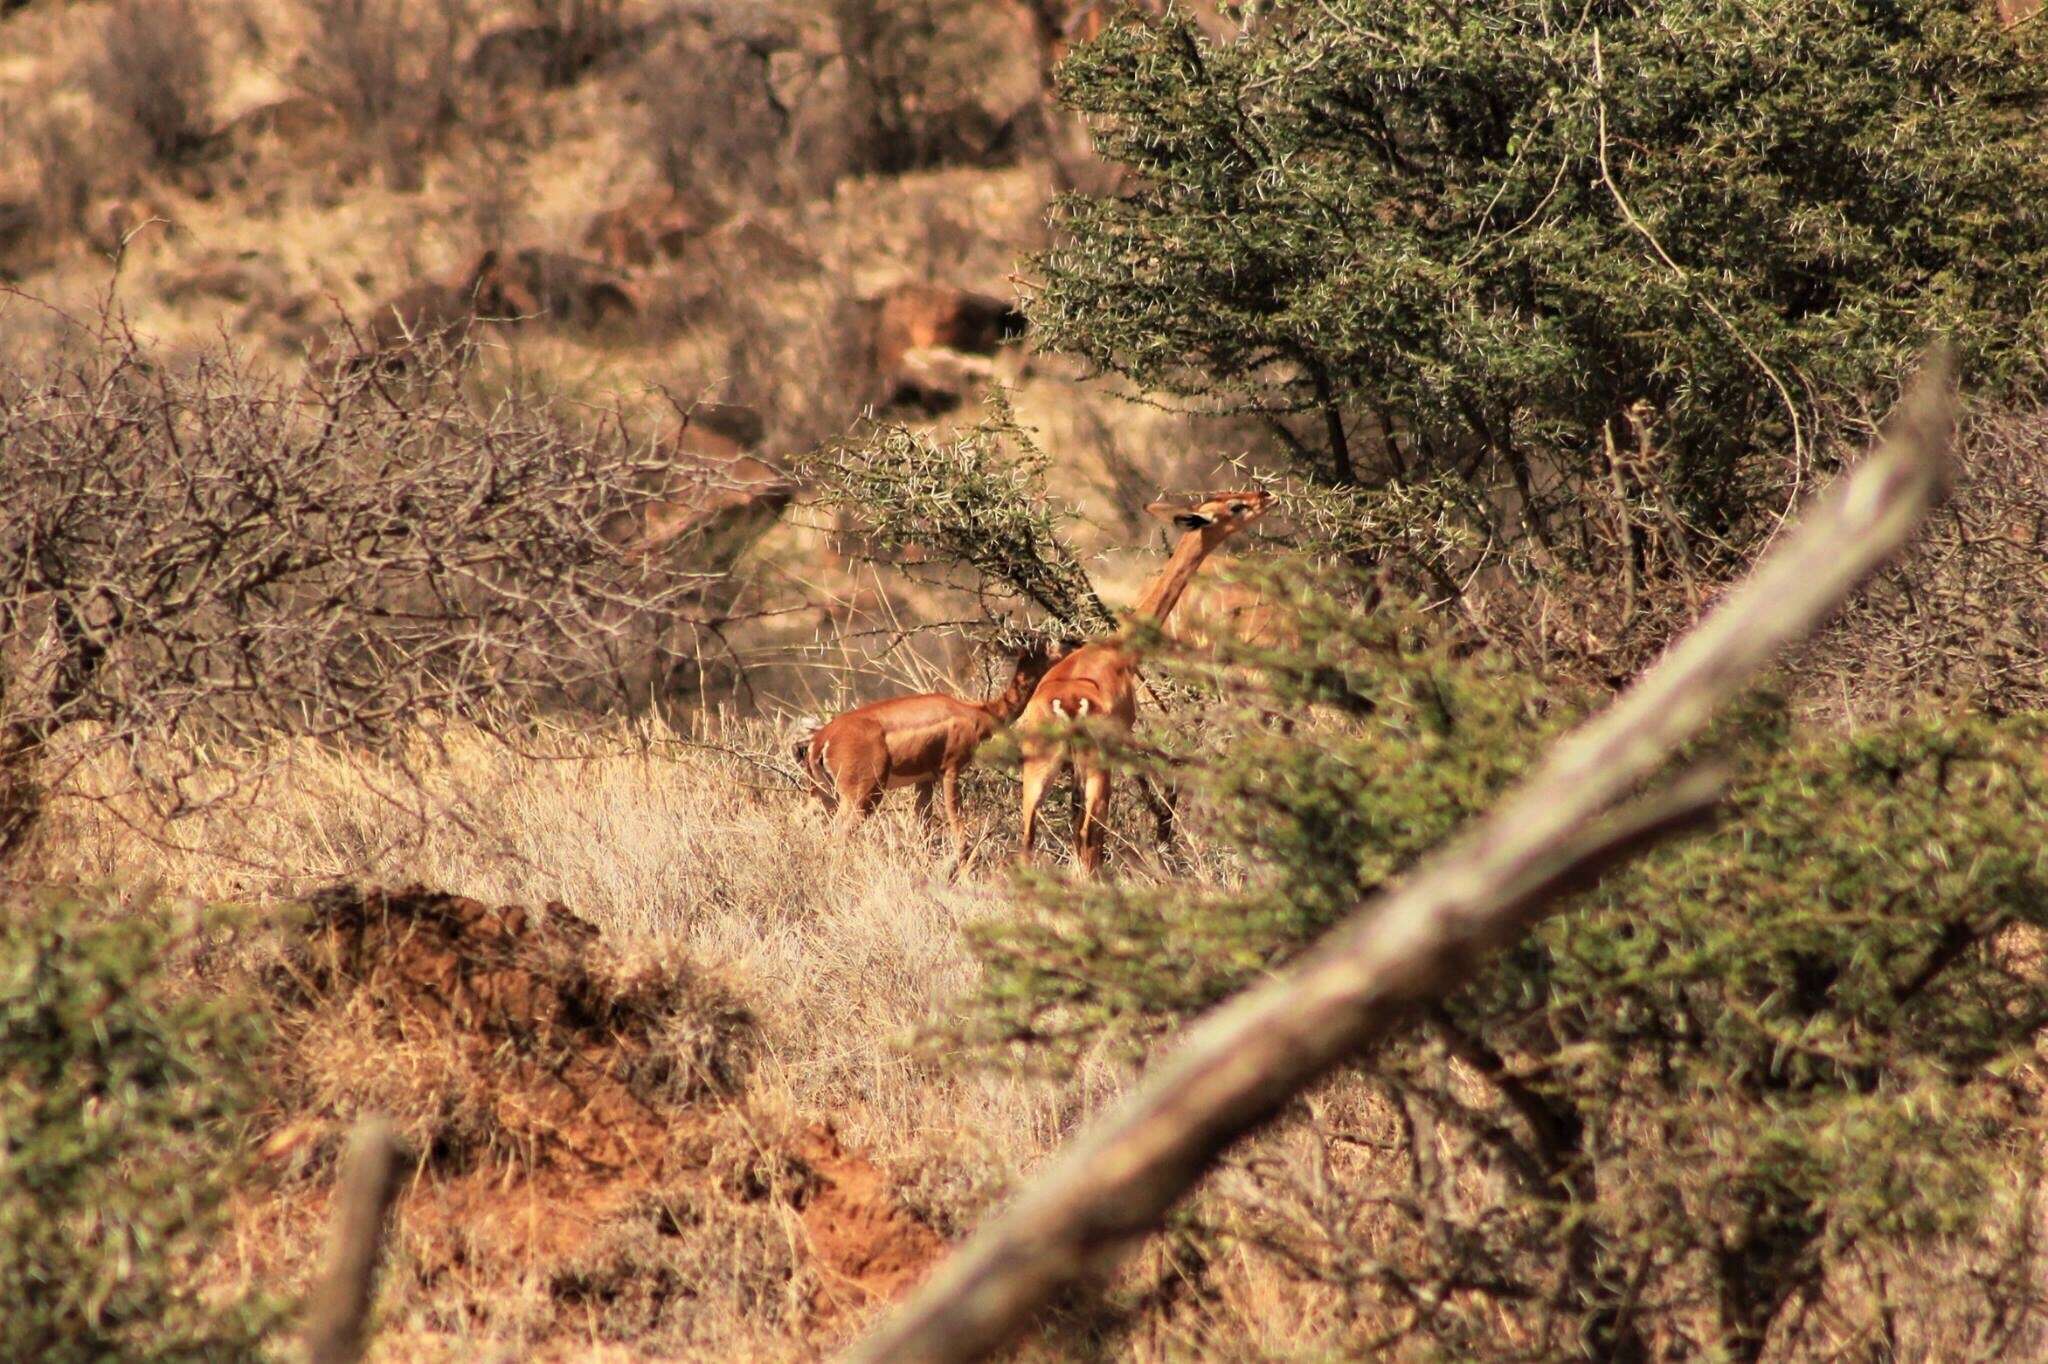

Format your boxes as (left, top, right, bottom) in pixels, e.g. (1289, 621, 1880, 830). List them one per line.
(969, 569, 2048, 1360)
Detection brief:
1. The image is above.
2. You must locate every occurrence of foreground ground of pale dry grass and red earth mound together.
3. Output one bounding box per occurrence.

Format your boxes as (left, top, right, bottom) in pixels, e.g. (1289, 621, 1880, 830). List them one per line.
(43, 720, 1386, 1358)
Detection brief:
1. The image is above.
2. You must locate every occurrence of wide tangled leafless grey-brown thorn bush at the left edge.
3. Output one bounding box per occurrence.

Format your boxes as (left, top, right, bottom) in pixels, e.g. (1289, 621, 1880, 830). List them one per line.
(0, 330, 749, 852)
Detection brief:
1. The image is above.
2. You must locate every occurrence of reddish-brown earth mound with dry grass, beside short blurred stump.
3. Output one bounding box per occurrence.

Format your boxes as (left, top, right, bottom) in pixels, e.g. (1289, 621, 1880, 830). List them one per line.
(240, 887, 944, 1354)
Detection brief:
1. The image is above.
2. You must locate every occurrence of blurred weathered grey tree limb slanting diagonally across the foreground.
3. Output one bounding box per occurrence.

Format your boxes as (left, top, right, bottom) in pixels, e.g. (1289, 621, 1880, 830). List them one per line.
(848, 354, 1954, 1364)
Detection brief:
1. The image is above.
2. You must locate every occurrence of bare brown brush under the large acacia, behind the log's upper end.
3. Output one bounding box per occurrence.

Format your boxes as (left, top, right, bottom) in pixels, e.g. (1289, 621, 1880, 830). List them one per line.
(1441, 401, 2048, 717)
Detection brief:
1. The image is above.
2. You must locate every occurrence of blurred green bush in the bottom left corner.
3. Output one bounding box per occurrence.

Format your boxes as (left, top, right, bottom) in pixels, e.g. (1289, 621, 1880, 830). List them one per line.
(0, 899, 268, 1364)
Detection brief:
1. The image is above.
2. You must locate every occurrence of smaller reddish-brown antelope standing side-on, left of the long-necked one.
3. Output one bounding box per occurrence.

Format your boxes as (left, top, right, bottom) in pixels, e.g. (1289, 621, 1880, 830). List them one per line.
(797, 641, 1067, 858)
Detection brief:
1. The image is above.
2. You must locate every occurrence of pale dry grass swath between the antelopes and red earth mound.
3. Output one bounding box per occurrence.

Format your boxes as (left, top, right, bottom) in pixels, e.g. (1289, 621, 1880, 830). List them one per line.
(39, 727, 1120, 1225)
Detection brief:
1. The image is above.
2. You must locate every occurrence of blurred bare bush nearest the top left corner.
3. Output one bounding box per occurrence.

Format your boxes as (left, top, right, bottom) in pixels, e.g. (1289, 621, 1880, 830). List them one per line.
(86, 0, 213, 162)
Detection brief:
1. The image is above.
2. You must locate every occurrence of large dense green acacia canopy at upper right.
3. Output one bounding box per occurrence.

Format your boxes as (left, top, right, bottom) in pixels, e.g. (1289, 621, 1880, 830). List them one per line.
(1032, 0, 2048, 528)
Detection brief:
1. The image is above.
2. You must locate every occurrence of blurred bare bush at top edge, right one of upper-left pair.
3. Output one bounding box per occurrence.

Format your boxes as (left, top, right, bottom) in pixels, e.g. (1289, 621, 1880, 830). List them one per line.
(297, 0, 473, 176)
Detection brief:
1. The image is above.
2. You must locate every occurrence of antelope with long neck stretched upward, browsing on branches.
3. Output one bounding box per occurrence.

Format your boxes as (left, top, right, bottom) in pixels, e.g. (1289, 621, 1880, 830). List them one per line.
(1018, 489, 1274, 877)
